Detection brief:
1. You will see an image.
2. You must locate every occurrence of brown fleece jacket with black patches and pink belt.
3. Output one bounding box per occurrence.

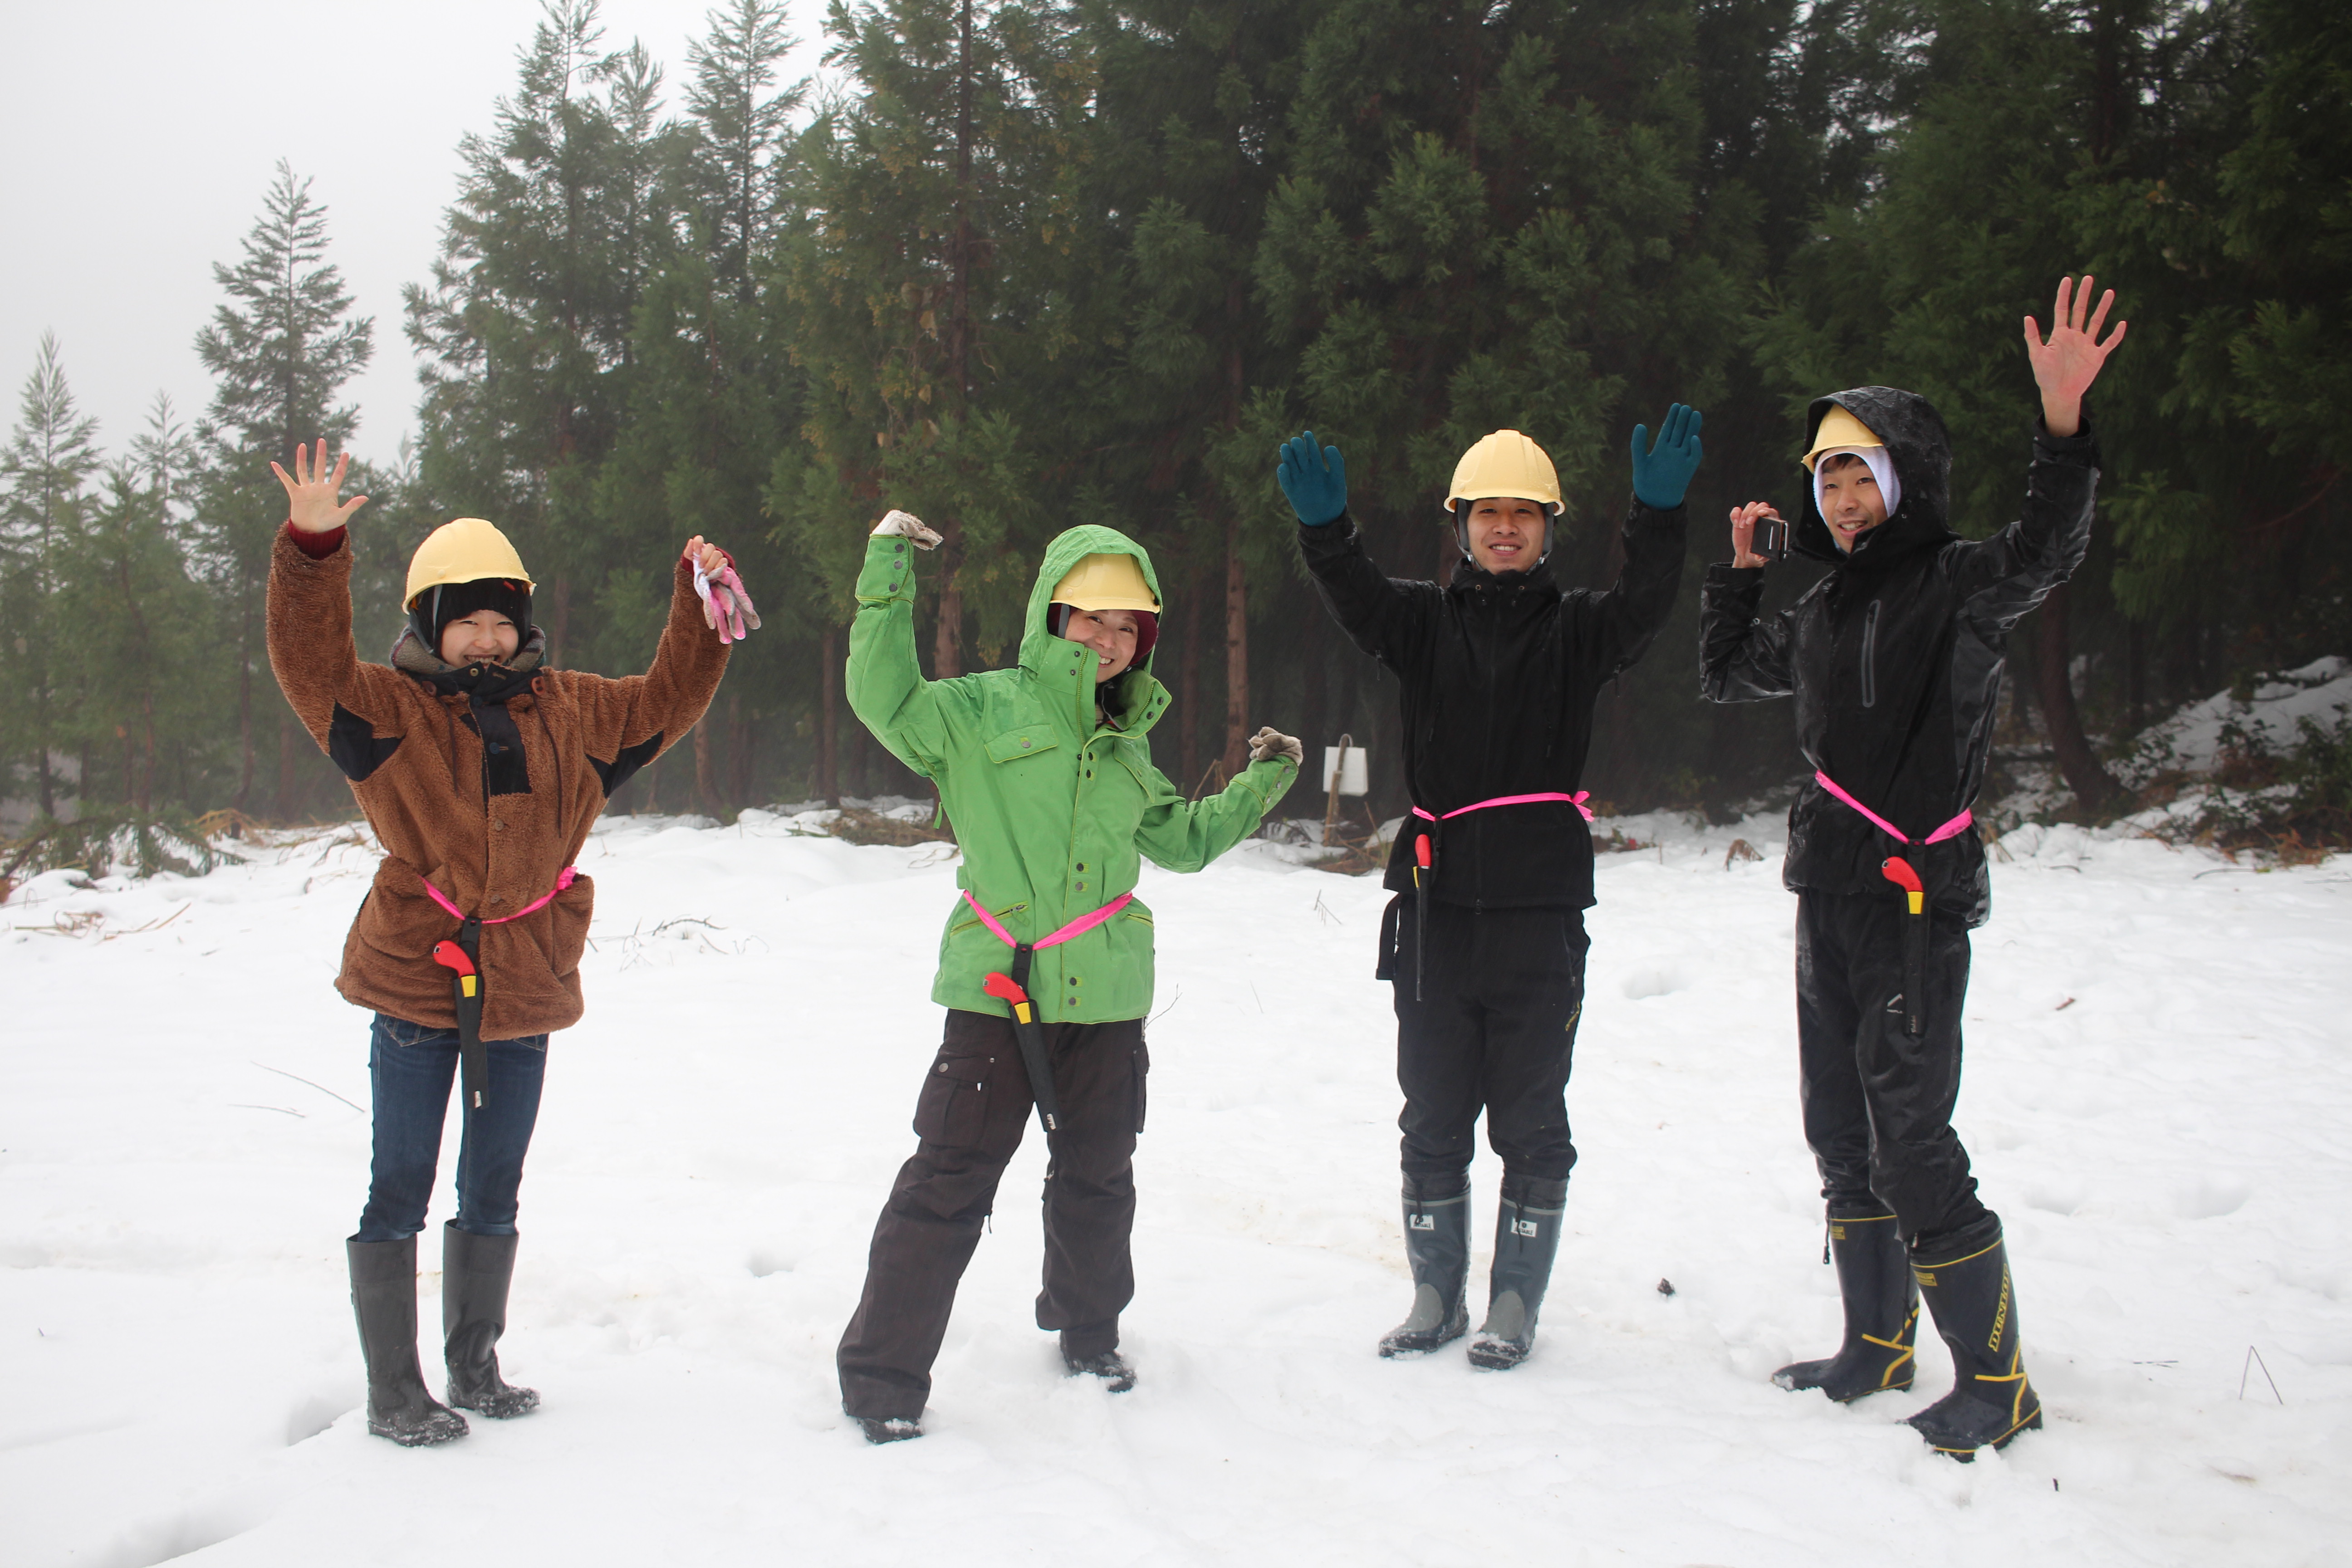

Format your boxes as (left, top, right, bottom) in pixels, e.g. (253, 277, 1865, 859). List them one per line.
(268, 529, 727, 1039)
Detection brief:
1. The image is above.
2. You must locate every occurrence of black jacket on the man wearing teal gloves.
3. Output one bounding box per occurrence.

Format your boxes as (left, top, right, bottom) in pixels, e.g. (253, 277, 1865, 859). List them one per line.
(1298, 501, 1686, 910)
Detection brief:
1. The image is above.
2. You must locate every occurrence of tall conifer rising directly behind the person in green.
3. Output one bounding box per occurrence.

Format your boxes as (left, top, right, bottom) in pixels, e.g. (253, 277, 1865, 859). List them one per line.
(771, 0, 1094, 677)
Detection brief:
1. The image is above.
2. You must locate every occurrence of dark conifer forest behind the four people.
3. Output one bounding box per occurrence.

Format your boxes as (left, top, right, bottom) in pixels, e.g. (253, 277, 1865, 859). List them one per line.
(0, 0, 2352, 841)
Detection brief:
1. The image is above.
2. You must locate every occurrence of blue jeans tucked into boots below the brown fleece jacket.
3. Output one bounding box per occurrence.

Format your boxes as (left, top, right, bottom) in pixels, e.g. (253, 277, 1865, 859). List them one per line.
(353, 1013, 548, 1241)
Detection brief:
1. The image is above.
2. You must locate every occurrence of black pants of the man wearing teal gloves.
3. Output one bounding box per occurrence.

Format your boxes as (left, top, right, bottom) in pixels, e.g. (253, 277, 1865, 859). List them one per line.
(1381, 893, 1590, 1196)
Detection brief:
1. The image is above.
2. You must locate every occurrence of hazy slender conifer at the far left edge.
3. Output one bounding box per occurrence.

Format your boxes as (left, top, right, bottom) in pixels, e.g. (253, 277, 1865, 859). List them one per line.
(0, 332, 99, 818)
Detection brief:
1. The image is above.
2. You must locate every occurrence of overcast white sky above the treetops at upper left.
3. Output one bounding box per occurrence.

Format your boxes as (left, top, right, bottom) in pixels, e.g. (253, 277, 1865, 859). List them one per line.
(0, 0, 823, 461)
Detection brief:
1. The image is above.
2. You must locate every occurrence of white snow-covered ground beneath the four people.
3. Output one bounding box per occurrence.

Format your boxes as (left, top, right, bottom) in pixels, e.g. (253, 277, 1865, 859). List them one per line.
(0, 816, 2352, 1568)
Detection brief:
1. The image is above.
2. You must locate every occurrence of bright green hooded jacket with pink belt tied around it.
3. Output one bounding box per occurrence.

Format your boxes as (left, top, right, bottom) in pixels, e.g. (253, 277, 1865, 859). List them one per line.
(849, 524, 1298, 1023)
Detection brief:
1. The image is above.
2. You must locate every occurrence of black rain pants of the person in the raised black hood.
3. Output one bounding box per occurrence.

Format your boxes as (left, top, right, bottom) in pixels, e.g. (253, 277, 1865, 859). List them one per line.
(1797, 891, 1994, 1241)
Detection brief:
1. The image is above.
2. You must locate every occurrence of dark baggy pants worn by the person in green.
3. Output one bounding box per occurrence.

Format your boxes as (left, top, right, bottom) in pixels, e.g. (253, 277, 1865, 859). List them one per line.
(835, 1011, 1150, 1420)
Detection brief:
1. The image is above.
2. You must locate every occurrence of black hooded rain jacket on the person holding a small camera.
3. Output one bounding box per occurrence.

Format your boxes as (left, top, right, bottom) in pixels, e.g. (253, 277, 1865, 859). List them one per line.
(1698, 386, 2098, 926)
